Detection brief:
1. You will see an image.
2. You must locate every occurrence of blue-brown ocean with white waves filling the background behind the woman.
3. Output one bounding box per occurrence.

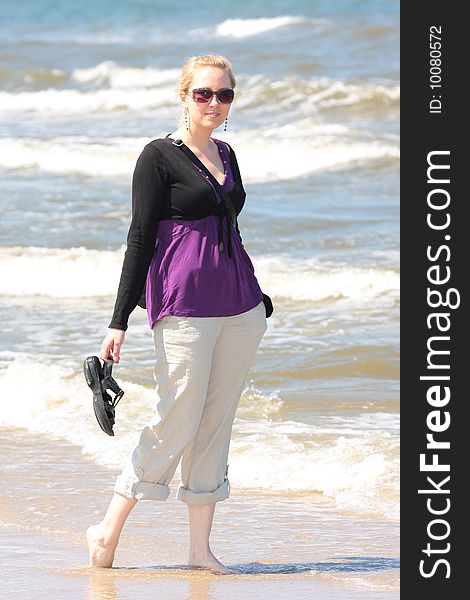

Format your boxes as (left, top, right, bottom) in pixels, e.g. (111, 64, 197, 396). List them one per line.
(0, 0, 400, 592)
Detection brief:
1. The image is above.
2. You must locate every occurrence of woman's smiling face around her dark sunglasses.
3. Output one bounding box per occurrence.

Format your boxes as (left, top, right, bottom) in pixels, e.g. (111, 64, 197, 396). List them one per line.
(181, 67, 232, 134)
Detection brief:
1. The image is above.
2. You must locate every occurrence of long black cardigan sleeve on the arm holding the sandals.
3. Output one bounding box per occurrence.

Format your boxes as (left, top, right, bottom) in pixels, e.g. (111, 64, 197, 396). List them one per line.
(108, 143, 168, 331)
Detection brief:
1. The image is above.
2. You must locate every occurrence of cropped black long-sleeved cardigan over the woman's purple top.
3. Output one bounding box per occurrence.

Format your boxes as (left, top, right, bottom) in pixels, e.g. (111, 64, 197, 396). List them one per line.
(109, 137, 246, 331)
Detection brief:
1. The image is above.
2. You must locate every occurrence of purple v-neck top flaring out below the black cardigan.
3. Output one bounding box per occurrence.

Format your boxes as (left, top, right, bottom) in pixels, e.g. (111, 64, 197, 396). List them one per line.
(145, 138, 263, 328)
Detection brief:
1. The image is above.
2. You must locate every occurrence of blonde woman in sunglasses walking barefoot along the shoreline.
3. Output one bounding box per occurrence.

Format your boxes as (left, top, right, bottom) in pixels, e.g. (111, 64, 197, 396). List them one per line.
(87, 55, 269, 573)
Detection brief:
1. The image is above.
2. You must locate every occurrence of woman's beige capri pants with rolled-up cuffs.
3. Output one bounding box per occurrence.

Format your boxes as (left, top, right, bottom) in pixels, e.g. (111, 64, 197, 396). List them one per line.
(114, 302, 267, 504)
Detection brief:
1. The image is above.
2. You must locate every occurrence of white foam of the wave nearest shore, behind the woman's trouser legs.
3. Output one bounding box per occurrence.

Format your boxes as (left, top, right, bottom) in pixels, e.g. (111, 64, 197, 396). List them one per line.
(0, 356, 399, 519)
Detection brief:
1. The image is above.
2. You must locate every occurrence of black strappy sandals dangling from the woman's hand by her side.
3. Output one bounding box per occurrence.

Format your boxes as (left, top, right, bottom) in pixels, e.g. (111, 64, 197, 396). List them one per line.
(83, 356, 124, 435)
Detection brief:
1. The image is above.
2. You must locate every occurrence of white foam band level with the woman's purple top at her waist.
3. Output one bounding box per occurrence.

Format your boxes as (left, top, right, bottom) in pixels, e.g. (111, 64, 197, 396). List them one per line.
(0, 246, 400, 304)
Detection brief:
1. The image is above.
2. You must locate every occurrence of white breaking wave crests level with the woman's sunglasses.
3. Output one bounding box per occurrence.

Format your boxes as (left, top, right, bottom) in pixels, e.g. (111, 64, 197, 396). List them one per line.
(0, 68, 400, 121)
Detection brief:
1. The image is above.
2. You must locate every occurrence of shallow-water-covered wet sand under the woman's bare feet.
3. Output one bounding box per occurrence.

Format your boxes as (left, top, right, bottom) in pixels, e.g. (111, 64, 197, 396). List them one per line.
(0, 430, 399, 600)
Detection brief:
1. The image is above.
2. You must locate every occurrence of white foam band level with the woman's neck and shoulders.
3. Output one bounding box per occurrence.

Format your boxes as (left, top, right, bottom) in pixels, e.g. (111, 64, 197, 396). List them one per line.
(0, 131, 399, 183)
